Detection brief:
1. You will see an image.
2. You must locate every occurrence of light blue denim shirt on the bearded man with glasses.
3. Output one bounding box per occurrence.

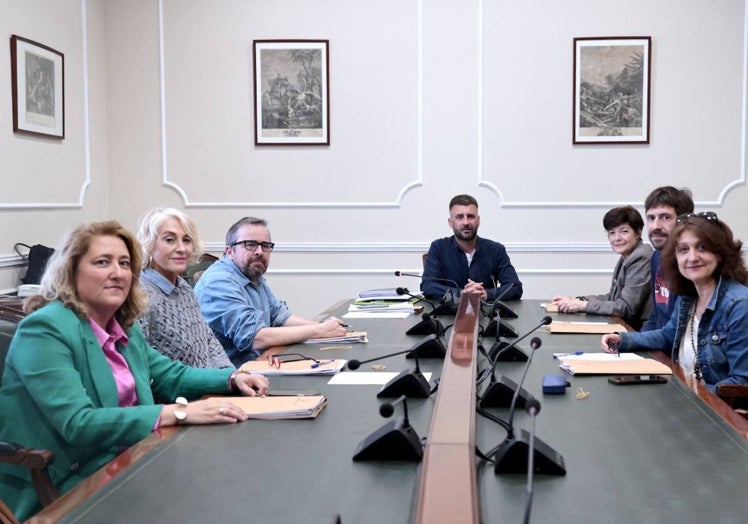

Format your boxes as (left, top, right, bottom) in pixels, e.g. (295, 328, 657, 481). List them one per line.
(195, 256, 291, 367)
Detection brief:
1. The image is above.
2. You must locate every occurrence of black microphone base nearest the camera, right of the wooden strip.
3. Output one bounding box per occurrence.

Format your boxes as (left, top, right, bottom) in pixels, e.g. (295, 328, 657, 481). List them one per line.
(494, 429, 566, 475)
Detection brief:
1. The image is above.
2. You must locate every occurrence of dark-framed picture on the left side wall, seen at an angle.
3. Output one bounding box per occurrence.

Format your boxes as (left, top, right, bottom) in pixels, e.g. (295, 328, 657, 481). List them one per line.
(10, 35, 65, 139)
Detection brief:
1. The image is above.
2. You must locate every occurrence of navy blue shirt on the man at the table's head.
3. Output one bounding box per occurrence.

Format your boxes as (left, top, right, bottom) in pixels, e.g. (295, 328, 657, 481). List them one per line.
(421, 236, 522, 301)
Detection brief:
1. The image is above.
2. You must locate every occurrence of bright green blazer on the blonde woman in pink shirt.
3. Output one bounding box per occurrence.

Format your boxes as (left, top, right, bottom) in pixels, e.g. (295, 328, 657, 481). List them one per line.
(0, 302, 232, 521)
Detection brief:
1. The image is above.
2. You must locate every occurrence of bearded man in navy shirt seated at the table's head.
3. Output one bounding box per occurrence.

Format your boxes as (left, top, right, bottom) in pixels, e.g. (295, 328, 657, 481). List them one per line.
(421, 195, 522, 301)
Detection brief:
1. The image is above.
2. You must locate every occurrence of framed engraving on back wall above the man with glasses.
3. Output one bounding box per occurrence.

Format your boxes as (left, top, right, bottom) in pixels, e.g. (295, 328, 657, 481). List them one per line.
(252, 40, 330, 146)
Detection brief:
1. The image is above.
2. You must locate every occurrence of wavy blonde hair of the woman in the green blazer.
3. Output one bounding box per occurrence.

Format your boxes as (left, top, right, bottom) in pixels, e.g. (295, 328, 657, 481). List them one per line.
(24, 220, 147, 329)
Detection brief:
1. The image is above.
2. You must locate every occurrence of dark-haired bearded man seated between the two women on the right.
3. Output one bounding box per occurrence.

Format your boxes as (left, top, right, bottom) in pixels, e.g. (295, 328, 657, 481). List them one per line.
(641, 186, 693, 331)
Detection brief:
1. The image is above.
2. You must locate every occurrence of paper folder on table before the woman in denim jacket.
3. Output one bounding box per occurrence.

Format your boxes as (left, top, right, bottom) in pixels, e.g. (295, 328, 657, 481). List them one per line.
(553, 352, 673, 375)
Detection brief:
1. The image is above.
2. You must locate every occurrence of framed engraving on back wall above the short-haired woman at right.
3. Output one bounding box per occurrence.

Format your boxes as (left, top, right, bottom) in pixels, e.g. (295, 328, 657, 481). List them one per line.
(572, 36, 652, 144)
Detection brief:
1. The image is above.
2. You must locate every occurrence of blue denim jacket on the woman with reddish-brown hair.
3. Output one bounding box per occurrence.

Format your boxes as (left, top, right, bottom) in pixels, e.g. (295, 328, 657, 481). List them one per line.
(620, 278, 748, 392)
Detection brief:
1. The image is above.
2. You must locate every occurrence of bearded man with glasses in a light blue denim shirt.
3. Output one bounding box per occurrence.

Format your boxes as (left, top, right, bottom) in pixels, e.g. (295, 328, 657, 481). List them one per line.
(195, 217, 346, 367)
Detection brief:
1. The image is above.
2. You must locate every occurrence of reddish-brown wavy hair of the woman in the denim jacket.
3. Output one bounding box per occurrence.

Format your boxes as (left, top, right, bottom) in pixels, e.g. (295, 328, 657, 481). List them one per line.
(662, 216, 748, 297)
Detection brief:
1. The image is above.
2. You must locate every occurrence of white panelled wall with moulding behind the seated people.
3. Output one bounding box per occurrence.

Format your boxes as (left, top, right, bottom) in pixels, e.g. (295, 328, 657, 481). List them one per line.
(0, 0, 748, 315)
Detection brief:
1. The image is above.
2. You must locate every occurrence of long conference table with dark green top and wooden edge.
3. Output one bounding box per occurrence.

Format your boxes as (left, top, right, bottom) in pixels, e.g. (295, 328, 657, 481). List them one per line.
(32, 300, 748, 523)
